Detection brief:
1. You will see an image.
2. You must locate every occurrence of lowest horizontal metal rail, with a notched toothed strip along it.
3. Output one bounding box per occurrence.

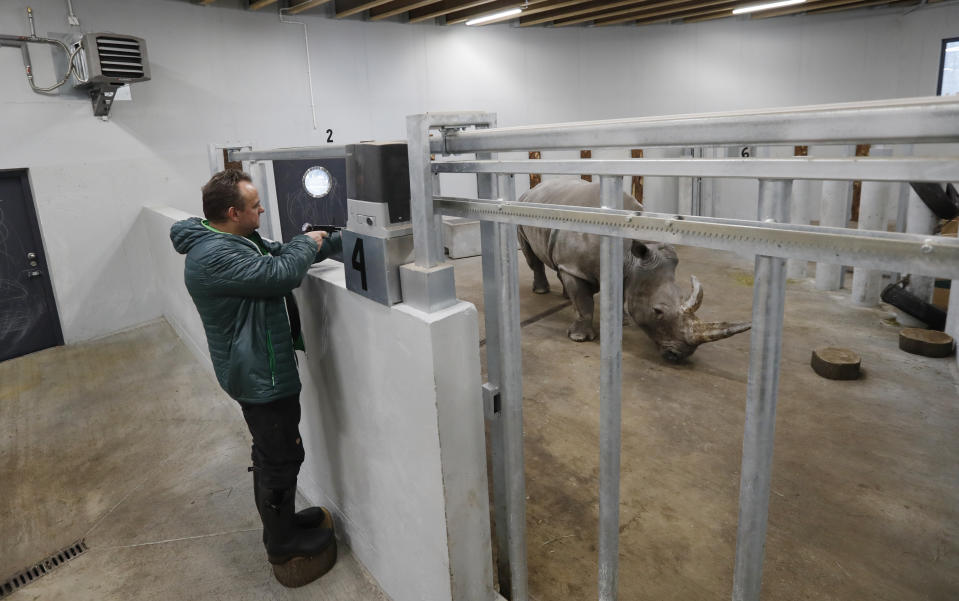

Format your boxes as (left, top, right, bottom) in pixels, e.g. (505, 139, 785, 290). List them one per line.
(436, 197, 959, 279)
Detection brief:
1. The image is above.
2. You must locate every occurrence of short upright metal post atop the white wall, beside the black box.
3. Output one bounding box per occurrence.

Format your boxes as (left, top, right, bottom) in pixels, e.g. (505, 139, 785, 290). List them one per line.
(406, 114, 443, 267)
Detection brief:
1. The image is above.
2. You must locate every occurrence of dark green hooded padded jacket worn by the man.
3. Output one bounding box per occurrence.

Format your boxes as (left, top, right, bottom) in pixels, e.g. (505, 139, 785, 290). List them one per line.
(170, 217, 342, 403)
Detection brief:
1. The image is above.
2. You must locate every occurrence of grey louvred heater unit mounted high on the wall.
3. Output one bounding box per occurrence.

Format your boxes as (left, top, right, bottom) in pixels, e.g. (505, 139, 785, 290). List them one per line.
(76, 33, 150, 117)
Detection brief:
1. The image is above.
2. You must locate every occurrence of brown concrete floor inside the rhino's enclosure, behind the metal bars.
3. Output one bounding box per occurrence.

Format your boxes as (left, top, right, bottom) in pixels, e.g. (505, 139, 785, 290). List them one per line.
(456, 248, 959, 601)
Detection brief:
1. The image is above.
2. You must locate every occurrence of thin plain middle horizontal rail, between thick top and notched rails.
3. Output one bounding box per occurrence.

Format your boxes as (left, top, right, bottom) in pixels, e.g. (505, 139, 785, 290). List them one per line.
(433, 157, 959, 183)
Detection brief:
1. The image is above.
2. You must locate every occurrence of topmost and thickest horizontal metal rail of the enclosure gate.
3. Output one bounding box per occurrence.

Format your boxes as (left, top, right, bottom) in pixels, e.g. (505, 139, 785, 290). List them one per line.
(430, 96, 959, 154)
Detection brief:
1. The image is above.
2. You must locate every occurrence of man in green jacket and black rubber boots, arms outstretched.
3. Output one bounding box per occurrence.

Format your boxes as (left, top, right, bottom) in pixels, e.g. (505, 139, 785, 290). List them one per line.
(170, 169, 342, 586)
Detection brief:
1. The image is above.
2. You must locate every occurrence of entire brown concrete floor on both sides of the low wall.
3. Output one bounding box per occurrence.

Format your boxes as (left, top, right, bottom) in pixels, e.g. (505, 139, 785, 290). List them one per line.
(0, 244, 959, 601)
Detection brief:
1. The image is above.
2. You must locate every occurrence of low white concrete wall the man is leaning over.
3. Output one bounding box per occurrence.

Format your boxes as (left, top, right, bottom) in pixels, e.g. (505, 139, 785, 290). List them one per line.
(137, 207, 494, 601)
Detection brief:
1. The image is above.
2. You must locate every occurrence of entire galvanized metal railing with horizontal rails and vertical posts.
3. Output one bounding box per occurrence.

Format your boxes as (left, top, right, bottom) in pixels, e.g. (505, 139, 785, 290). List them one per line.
(407, 98, 959, 601)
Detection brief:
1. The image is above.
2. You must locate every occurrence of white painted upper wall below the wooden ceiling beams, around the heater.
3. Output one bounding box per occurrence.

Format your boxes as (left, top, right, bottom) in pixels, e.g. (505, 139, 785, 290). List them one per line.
(0, 0, 959, 343)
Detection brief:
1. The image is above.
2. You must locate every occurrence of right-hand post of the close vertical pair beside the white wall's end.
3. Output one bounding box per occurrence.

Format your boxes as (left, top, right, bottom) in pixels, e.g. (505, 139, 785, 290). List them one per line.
(494, 175, 529, 601)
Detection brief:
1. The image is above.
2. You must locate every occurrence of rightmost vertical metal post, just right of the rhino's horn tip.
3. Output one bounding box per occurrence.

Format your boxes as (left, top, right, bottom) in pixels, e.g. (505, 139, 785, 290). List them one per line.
(733, 180, 792, 601)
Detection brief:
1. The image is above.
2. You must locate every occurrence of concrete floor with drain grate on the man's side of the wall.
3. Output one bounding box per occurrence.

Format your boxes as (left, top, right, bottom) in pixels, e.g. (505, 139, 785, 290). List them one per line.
(0, 322, 387, 601)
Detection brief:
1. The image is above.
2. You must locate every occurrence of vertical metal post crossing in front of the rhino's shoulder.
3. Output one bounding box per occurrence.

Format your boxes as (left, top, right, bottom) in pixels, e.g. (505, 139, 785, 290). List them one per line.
(599, 176, 623, 601)
